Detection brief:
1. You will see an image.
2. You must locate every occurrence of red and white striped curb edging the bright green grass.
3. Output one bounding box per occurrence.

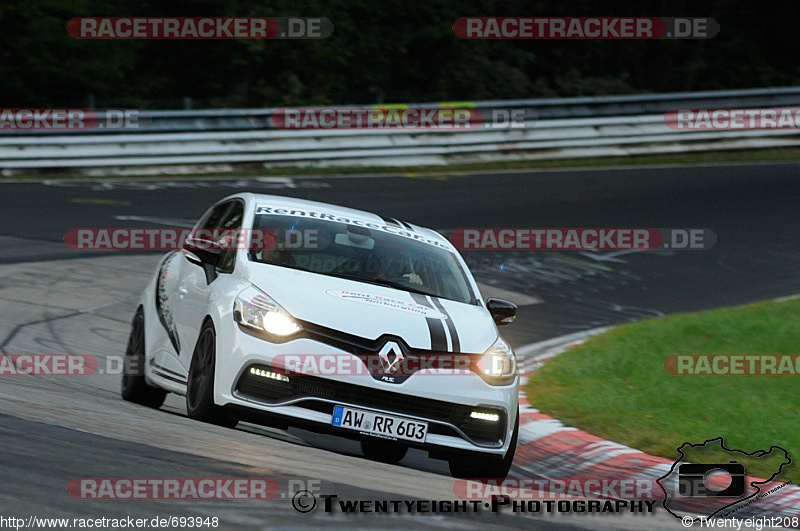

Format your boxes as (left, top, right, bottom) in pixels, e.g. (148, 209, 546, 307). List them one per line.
(513, 328, 800, 519)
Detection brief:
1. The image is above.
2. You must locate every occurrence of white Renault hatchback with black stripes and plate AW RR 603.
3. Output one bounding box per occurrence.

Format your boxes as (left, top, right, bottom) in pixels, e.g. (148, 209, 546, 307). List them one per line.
(122, 193, 519, 478)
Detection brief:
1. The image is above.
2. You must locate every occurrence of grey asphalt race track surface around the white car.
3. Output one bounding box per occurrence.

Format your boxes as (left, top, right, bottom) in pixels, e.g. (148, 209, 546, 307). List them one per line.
(0, 163, 800, 529)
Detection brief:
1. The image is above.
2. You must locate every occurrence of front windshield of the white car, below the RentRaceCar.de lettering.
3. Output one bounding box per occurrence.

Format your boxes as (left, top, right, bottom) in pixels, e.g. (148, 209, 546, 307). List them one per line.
(249, 214, 475, 304)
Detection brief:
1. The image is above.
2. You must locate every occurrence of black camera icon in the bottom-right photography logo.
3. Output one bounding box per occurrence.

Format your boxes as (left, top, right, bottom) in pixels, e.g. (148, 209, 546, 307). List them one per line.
(678, 461, 746, 498)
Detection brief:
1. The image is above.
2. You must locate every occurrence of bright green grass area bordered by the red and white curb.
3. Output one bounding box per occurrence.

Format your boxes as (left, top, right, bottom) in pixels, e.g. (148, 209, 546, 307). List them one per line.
(526, 298, 800, 484)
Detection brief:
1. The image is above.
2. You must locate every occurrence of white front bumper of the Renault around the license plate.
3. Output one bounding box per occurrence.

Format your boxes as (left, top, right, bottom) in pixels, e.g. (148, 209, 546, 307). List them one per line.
(215, 326, 519, 456)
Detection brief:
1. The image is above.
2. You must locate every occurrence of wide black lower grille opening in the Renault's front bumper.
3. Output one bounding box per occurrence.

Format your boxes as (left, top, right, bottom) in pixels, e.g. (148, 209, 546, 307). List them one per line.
(236, 365, 506, 446)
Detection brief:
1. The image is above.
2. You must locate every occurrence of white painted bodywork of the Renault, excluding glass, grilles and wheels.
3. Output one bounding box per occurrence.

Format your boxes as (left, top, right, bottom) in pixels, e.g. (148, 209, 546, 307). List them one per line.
(140, 193, 519, 455)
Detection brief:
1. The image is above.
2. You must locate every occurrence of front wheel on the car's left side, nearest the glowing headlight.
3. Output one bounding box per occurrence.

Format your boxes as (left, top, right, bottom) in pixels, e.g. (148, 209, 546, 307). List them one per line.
(186, 321, 239, 428)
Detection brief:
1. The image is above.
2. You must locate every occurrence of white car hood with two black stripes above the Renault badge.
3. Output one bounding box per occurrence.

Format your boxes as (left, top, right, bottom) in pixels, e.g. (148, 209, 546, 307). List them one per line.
(247, 264, 497, 353)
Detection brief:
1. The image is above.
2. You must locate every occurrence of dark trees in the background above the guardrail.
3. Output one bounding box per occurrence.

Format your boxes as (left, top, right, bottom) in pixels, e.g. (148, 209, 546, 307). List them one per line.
(0, 0, 800, 108)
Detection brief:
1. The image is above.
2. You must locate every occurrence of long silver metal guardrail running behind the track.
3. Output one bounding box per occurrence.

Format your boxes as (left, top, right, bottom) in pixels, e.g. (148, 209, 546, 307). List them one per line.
(0, 87, 800, 175)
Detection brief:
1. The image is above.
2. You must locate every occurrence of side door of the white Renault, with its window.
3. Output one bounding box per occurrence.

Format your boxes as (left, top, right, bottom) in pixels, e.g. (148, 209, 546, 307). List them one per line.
(175, 199, 244, 370)
